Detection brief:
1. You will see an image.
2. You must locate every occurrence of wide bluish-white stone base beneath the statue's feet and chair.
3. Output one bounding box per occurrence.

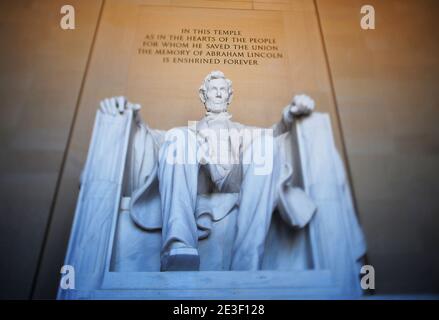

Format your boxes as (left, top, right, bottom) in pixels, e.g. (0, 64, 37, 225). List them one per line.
(58, 271, 360, 300)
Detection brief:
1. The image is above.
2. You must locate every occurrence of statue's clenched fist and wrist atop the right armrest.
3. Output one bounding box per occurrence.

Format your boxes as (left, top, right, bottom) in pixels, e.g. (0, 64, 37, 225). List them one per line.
(271, 94, 315, 137)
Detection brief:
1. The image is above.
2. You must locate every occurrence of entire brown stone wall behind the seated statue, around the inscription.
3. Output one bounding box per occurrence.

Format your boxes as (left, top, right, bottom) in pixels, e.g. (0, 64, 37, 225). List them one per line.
(0, 0, 439, 298)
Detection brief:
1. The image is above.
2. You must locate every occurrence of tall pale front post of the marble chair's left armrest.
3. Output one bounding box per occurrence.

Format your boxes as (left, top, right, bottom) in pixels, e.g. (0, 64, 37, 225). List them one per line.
(59, 107, 133, 298)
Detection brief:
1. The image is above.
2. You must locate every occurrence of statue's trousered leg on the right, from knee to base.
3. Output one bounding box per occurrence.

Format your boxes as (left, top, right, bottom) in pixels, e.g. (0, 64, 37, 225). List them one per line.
(231, 135, 281, 270)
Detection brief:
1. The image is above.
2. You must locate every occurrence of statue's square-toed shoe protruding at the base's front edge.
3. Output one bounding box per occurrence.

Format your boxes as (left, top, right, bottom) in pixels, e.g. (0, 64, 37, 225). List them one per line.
(160, 248, 200, 271)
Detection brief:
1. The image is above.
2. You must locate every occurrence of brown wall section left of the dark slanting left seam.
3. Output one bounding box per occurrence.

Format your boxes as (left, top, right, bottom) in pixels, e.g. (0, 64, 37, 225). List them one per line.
(0, 0, 100, 298)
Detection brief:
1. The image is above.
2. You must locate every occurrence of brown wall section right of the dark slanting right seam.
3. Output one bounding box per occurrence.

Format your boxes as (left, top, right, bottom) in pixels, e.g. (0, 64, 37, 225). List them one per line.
(317, 0, 439, 293)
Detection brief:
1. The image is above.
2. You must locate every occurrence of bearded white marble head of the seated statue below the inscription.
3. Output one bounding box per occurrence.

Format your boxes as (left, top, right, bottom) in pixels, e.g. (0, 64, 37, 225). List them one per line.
(199, 71, 233, 113)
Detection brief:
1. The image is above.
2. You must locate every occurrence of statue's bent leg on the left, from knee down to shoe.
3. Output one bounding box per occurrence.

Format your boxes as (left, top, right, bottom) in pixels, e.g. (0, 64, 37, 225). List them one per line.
(158, 128, 199, 271)
